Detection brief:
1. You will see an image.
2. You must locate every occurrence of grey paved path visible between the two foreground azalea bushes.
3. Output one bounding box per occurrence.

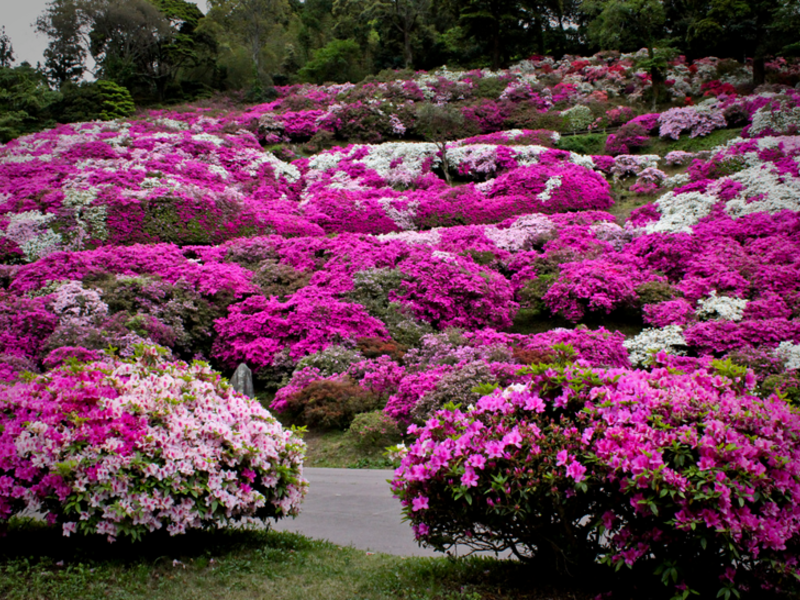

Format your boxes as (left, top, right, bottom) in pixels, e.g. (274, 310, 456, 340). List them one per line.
(274, 468, 441, 556)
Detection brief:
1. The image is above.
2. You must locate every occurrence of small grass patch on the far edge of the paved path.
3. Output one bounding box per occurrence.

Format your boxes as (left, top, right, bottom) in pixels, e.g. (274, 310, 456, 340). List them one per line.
(303, 431, 395, 469)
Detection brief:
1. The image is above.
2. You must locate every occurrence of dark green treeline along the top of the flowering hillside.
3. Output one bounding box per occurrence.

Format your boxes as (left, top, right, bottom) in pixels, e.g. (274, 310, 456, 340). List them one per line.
(0, 0, 800, 139)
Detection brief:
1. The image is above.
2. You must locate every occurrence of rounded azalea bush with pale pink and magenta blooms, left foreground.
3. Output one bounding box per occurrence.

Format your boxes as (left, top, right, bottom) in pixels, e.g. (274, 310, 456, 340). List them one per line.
(0, 347, 308, 541)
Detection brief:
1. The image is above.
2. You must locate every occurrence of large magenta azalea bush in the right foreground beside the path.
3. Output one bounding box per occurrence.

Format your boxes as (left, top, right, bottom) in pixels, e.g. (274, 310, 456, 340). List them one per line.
(392, 354, 800, 594)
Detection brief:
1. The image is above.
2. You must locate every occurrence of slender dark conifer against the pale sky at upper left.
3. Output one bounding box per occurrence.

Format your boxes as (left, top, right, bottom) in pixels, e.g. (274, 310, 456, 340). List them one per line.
(36, 0, 87, 88)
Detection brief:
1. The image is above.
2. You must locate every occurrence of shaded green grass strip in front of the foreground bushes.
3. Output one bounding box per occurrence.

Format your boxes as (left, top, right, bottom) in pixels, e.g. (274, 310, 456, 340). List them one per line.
(0, 524, 603, 600)
